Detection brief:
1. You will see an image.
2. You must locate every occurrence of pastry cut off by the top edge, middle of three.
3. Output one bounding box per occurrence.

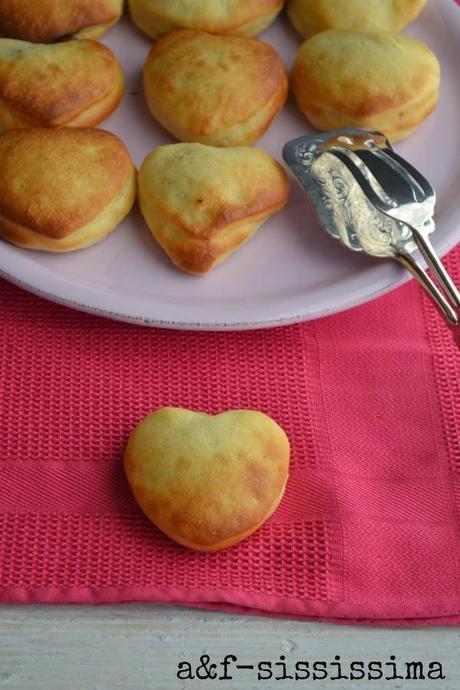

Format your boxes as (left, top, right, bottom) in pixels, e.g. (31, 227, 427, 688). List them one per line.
(129, 0, 284, 38)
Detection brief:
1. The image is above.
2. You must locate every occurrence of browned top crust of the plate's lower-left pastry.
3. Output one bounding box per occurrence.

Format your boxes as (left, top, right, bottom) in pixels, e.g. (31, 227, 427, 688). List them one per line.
(0, 128, 133, 239)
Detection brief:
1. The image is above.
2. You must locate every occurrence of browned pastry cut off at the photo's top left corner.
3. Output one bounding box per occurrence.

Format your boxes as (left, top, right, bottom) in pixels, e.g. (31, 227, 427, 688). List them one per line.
(0, 0, 123, 43)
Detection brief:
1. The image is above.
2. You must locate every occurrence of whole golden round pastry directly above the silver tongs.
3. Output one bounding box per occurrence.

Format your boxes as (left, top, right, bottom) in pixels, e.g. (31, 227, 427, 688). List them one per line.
(291, 31, 440, 141)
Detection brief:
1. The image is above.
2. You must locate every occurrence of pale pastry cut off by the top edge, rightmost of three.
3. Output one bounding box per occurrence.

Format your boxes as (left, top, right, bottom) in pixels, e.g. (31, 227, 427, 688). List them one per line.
(287, 0, 426, 38)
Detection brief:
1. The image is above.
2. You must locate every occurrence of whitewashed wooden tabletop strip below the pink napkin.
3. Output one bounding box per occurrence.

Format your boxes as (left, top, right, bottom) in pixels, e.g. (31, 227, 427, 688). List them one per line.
(0, 606, 460, 690)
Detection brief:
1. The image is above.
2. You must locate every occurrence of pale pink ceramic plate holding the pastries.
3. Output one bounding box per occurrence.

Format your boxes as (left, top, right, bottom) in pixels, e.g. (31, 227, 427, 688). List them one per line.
(0, 0, 460, 330)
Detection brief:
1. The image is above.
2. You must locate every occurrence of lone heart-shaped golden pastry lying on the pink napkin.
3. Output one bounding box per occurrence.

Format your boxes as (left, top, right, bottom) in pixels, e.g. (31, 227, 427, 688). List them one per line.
(124, 407, 290, 551)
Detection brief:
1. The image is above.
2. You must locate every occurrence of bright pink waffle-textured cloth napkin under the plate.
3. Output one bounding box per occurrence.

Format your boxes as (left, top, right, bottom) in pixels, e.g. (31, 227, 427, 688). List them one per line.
(0, 242, 460, 623)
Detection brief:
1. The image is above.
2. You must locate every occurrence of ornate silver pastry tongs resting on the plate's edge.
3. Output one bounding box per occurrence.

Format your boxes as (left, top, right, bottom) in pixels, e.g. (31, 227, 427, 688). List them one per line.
(284, 128, 460, 345)
